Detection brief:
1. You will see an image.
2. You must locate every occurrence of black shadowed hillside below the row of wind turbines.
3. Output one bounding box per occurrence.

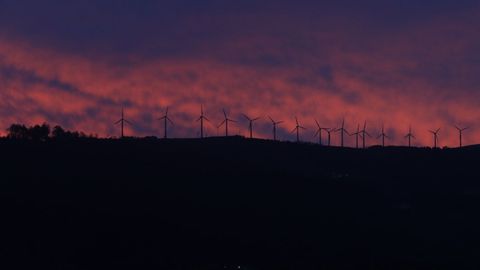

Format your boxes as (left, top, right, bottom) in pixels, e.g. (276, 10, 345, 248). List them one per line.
(0, 137, 480, 269)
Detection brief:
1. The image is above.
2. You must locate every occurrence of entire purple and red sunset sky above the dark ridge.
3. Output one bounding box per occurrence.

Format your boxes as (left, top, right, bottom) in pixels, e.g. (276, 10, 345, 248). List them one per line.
(0, 0, 480, 147)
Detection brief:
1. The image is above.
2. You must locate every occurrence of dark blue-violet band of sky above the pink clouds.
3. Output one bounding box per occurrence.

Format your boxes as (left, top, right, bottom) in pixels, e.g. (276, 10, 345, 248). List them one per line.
(0, 0, 478, 55)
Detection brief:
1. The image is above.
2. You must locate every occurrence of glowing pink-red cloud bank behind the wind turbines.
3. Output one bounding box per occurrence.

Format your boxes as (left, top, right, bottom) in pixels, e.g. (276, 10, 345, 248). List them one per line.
(0, 9, 480, 146)
